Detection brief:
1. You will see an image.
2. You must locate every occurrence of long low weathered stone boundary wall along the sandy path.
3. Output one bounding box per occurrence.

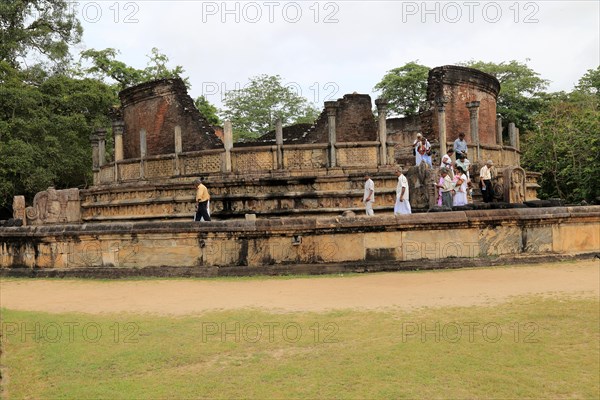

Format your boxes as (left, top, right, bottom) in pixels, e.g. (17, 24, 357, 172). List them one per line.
(0, 206, 600, 277)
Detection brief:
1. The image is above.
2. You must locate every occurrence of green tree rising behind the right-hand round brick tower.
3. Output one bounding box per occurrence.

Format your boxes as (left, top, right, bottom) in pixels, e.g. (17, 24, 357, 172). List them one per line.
(459, 60, 548, 131)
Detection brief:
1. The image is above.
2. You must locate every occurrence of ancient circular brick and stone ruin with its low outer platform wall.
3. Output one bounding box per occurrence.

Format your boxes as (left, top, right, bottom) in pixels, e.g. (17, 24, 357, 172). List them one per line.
(0, 66, 600, 276)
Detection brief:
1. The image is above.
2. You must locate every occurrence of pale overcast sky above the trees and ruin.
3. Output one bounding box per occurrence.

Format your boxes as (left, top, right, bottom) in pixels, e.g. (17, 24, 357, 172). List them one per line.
(73, 0, 600, 108)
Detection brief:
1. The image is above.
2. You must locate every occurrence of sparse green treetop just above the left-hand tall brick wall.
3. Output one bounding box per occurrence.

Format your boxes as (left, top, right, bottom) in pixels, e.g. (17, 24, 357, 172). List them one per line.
(79, 47, 189, 90)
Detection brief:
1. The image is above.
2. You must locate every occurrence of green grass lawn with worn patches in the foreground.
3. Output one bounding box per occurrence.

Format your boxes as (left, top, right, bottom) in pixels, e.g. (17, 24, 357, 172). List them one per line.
(0, 296, 600, 399)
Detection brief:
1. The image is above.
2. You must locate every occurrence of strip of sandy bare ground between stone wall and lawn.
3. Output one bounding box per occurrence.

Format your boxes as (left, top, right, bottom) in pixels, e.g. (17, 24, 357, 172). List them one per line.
(0, 260, 600, 315)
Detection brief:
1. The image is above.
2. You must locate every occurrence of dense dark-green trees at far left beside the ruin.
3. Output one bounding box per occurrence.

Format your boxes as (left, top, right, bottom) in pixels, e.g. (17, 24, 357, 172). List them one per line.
(0, 65, 116, 208)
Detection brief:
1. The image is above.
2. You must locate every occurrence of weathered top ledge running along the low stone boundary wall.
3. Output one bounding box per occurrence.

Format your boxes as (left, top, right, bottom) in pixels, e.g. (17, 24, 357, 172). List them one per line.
(0, 206, 600, 239)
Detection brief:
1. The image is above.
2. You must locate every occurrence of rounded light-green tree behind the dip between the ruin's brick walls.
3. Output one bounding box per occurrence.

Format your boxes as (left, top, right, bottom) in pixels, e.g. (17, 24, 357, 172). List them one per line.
(221, 75, 318, 139)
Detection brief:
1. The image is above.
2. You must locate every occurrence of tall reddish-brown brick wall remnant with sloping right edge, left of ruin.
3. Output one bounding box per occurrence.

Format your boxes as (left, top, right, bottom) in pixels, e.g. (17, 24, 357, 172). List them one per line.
(119, 79, 223, 159)
